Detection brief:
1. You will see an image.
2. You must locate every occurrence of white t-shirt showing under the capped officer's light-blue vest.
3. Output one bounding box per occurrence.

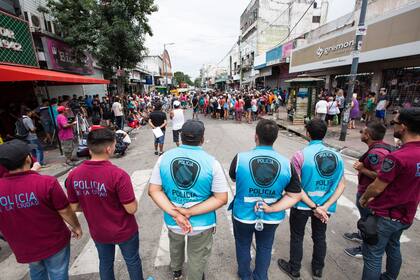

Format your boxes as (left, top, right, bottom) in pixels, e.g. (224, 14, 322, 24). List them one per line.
(149, 154, 229, 236)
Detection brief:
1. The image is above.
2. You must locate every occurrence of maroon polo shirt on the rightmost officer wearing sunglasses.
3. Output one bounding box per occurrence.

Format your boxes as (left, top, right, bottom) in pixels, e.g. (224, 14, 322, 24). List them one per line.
(369, 141, 420, 224)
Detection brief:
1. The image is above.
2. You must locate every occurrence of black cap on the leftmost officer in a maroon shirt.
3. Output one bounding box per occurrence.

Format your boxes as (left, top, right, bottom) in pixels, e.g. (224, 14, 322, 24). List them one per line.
(0, 139, 34, 170)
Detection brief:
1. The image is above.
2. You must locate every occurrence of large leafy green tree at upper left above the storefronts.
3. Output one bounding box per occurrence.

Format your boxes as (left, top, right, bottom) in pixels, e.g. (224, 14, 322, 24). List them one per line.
(48, 0, 157, 83)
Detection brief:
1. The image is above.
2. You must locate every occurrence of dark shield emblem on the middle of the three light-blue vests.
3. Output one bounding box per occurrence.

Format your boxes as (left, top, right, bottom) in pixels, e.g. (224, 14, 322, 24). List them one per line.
(249, 156, 281, 188)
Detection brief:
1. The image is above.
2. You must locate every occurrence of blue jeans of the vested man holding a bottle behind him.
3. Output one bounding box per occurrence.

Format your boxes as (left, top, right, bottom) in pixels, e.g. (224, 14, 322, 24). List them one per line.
(232, 218, 278, 280)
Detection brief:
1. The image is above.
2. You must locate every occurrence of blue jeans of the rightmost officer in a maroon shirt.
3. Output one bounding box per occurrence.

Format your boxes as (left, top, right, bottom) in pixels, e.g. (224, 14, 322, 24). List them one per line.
(362, 217, 409, 280)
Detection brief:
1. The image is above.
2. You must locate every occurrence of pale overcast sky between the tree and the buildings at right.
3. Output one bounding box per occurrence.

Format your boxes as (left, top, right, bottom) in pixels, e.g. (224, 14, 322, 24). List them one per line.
(146, 0, 354, 78)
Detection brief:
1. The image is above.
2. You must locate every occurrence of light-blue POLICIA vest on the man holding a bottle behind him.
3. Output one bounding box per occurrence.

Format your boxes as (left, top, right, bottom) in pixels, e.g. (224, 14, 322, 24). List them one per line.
(233, 146, 292, 224)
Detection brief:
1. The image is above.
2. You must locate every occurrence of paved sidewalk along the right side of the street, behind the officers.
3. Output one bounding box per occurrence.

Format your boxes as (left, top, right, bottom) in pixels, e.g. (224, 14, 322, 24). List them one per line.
(264, 107, 394, 158)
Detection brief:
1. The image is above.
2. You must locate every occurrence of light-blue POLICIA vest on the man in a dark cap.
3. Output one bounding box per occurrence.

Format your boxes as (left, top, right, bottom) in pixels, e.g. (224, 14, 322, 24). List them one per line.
(160, 145, 216, 231)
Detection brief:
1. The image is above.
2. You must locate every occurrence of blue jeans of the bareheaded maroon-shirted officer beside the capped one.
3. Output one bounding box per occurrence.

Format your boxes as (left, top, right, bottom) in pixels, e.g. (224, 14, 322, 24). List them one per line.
(95, 232, 143, 280)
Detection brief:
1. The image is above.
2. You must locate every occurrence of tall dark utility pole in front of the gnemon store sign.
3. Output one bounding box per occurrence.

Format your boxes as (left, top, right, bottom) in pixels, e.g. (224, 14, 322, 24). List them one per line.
(339, 0, 368, 141)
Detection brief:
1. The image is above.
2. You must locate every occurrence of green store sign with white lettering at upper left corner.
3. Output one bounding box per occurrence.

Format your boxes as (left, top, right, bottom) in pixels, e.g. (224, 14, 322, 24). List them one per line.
(0, 12, 38, 67)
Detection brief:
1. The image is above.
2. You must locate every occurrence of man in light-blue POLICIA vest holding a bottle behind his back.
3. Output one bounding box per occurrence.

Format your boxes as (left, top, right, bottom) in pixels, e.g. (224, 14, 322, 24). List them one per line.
(229, 120, 301, 280)
